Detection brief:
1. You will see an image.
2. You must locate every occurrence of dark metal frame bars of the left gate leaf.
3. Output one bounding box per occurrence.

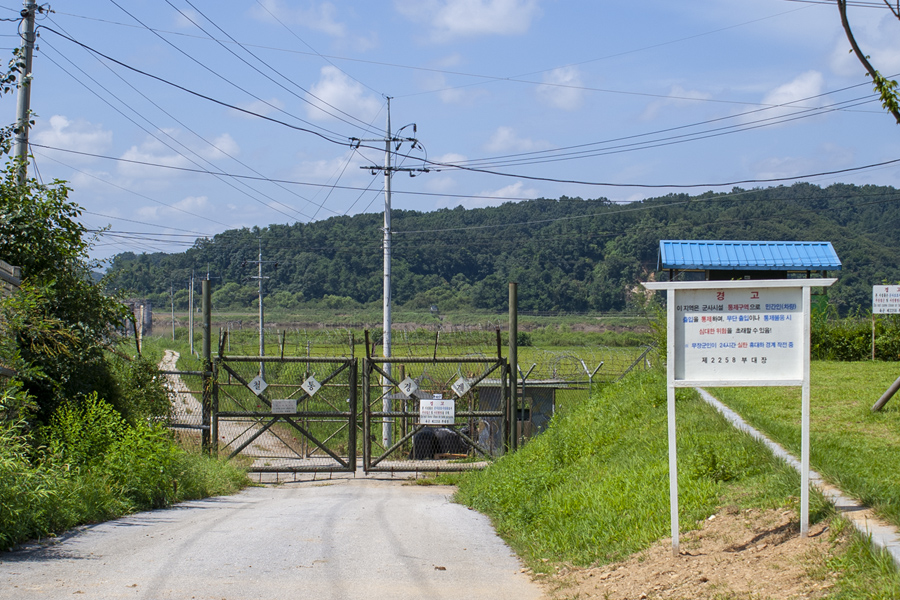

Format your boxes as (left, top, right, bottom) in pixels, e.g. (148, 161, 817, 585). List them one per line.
(211, 356, 359, 473)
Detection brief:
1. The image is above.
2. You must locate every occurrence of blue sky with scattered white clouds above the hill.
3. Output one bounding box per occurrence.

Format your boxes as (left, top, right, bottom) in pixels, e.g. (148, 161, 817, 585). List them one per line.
(0, 0, 900, 258)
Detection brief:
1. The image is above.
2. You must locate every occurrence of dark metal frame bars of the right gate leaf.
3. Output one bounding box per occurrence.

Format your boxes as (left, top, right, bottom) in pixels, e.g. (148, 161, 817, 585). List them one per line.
(362, 334, 510, 473)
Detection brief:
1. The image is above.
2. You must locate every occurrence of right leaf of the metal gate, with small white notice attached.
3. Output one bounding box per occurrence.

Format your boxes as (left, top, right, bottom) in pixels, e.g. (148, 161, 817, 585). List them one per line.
(362, 341, 510, 472)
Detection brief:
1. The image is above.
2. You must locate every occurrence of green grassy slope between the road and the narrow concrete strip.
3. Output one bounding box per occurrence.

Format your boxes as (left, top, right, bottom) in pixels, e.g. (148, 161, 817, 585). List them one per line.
(457, 370, 808, 565)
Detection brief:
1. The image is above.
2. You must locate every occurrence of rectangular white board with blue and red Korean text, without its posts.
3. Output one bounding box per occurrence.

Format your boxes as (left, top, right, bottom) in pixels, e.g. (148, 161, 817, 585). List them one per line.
(670, 287, 805, 382)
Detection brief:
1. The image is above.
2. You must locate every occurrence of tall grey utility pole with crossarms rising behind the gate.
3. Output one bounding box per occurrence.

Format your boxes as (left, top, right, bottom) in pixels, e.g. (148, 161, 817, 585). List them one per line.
(353, 97, 428, 448)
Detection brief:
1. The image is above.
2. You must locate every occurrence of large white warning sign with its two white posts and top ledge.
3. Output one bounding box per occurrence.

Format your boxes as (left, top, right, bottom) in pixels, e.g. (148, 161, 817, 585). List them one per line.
(643, 279, 837, 555)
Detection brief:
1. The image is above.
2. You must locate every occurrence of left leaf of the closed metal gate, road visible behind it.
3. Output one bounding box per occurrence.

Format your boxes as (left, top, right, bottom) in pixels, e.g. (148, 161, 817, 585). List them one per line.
(211, 355, 358, 472)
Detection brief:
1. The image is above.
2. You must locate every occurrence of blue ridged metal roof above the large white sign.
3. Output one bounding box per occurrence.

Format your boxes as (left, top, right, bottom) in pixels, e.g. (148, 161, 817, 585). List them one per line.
(659, 240, 841, 271)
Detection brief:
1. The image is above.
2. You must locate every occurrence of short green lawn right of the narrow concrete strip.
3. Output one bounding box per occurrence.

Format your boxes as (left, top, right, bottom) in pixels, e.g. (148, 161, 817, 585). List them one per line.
(709, 361, 900, 526)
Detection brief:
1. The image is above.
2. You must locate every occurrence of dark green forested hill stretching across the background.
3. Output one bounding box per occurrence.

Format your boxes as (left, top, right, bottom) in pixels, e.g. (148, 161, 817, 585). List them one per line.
(103, 183, 900, 313)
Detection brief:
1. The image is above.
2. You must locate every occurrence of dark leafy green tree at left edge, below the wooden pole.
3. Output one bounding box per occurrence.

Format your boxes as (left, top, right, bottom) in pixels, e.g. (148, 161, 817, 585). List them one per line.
(0, 161, 127, 422)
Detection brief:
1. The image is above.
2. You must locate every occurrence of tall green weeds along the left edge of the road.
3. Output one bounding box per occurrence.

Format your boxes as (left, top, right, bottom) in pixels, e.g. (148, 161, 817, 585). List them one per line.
(0, 397, 247, 550)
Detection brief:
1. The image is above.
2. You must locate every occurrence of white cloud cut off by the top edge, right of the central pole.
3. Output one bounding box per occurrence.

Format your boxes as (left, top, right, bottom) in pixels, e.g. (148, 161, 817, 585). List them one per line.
(394, 0, 540, 41)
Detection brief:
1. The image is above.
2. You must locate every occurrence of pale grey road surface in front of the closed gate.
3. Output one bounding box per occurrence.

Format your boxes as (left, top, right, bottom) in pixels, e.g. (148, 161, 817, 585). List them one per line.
(0, 478, 545, 600)
